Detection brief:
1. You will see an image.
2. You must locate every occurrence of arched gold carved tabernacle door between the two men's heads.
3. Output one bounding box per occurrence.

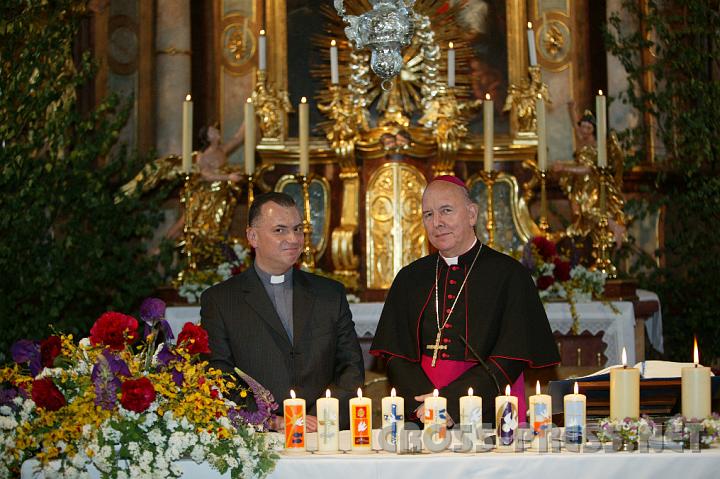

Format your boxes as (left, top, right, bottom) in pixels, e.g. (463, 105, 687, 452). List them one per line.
(365, 163, 428, 289)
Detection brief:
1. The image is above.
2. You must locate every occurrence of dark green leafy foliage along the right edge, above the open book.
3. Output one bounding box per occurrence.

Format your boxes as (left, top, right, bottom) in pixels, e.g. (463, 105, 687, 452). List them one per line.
(607, 0, 720, 363)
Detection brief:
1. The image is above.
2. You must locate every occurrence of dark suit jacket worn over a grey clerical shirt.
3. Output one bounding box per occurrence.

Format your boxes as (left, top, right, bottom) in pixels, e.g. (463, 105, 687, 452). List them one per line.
(200, 268, 365, 428)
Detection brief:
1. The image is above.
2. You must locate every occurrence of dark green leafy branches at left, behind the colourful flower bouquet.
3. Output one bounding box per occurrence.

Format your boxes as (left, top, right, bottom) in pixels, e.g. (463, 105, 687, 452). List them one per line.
(0, 0, 172, 362)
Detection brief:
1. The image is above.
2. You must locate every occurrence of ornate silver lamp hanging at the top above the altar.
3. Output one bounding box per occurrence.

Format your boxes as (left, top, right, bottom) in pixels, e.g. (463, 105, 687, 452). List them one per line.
(334, 0, 415, 90)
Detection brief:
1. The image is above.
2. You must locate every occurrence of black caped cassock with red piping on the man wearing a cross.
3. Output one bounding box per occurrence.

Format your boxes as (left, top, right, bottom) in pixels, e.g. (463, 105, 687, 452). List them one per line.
(370, 241, 560, 422)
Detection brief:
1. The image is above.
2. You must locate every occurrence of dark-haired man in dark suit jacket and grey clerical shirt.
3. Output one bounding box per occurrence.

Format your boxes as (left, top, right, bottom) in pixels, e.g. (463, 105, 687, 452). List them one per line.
(200, 192, 365, 431)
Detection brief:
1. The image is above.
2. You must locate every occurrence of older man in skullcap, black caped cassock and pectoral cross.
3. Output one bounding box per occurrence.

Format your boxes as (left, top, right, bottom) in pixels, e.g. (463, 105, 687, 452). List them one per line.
(370, 176, 560, 423)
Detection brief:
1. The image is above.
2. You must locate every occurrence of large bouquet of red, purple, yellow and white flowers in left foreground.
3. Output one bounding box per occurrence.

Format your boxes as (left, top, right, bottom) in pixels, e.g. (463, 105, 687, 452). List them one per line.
(0, 300, 279, 478)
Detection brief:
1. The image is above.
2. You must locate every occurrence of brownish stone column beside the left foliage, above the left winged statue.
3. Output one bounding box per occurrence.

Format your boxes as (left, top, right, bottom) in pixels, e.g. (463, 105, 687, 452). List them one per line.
(155, 0, 191, 156)
